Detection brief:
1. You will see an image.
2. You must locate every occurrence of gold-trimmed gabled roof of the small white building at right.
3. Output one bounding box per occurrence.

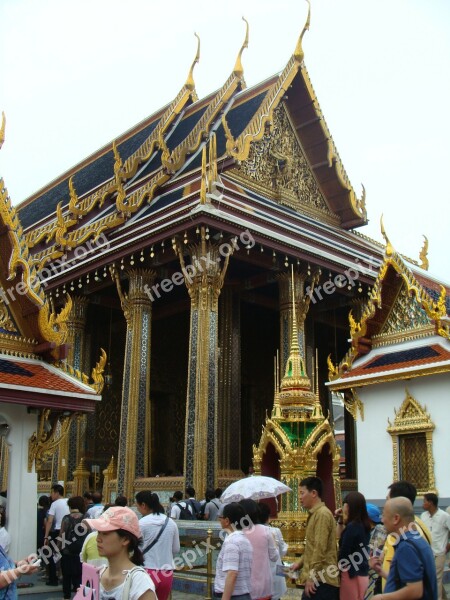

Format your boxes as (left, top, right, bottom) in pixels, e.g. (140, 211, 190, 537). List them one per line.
(328, 229, 450, 390)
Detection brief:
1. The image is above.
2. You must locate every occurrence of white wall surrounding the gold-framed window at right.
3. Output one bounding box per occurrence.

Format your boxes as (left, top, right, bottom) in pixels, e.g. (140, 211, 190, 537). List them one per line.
(356, 373, 450, 499)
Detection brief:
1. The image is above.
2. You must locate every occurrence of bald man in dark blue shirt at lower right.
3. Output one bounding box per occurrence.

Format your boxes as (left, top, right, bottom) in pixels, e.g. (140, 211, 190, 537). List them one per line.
(372, 496, 437, 600)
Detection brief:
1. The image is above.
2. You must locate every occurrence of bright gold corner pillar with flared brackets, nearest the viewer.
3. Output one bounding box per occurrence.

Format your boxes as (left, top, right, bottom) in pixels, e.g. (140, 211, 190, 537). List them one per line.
(174, 227, 233, 498)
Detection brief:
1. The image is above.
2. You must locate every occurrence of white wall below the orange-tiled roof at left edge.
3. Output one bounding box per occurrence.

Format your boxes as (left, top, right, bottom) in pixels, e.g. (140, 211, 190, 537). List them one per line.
(0, 404, 37, 560)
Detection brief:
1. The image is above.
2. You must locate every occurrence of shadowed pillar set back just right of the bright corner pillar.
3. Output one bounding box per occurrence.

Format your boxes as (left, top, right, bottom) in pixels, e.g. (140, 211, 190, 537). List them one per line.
(217, 286, 242, 478)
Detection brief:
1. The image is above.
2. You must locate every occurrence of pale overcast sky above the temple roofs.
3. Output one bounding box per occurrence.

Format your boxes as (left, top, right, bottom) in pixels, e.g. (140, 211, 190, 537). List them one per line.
(0, 0, 450, 281)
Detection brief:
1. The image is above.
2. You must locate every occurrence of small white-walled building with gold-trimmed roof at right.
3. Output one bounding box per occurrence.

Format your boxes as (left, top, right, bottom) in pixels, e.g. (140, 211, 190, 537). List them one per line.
(328, 236, 450, 506)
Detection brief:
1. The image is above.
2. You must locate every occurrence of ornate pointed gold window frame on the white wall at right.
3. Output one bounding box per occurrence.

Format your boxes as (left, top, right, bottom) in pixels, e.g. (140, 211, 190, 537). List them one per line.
(387, 389, 436, 494)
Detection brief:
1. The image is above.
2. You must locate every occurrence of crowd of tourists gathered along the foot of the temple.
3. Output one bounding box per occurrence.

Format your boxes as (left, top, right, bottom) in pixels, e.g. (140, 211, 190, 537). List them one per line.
(0, 477, 450, 600)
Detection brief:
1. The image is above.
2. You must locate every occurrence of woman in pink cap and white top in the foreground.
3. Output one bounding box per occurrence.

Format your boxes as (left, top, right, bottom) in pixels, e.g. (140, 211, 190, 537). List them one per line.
(85, 506, 156, 600)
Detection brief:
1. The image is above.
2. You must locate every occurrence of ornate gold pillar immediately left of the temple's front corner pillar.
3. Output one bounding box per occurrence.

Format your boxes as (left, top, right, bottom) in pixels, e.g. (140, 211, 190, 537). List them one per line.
(112, 269, 156, 499)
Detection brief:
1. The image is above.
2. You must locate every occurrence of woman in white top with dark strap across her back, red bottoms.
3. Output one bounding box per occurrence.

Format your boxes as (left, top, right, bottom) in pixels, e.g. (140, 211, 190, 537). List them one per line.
(136, 491, 180, 600)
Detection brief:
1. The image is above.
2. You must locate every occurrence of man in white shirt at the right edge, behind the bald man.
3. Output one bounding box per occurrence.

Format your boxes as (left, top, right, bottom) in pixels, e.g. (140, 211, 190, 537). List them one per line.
(421, 493, 450, 600)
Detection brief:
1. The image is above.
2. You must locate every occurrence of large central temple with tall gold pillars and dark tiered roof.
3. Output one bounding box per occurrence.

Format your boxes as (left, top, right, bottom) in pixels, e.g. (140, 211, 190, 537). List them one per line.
(0, 8, 449, 544)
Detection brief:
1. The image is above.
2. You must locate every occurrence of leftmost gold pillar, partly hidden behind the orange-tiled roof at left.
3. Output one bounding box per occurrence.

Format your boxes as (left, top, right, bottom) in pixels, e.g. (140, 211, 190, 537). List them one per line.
(63, 296, 89, 482)
